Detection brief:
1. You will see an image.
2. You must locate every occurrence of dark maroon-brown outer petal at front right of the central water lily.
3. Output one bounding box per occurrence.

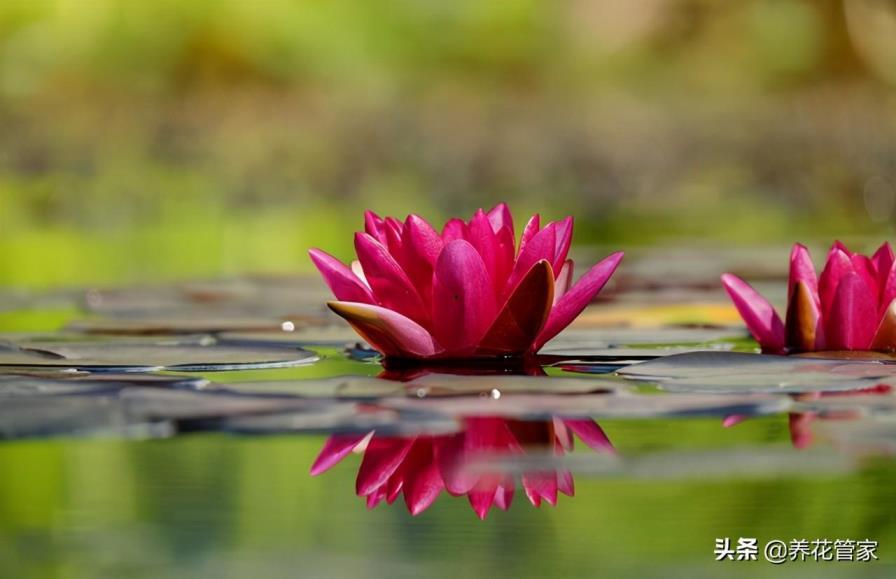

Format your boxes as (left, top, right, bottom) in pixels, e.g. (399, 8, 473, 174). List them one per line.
(477, 260, 554, 355)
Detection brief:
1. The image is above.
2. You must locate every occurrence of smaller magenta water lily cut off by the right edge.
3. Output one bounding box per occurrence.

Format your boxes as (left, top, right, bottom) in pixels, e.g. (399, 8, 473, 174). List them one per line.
(722, 241, 896, 354)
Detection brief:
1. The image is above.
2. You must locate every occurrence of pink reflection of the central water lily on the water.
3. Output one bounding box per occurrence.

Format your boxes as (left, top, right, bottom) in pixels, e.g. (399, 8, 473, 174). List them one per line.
(311, 416, 613, 519)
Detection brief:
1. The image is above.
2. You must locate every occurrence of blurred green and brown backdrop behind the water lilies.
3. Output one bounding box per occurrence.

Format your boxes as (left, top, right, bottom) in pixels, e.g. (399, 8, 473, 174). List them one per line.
(0, 0, 896, 288)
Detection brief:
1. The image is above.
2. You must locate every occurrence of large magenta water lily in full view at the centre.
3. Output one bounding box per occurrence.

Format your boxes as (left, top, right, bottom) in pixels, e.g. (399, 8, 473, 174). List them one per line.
(309, 203, 622, 359)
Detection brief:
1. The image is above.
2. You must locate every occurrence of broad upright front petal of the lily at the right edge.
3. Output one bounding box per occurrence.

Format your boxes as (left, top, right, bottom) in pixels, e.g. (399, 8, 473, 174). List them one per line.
(824, 273, 877, 350)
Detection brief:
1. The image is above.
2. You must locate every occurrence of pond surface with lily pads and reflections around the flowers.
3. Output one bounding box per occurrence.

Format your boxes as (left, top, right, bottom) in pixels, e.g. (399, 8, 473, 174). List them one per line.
(0, 254, 896, 579)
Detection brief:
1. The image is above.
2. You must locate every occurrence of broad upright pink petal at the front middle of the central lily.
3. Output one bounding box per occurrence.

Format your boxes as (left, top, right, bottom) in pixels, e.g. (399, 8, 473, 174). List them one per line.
(432, 239, 496, 351)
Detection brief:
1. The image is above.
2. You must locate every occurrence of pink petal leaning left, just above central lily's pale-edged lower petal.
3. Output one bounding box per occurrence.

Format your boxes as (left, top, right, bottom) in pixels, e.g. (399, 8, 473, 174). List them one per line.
(355, 233, 429, 326)
